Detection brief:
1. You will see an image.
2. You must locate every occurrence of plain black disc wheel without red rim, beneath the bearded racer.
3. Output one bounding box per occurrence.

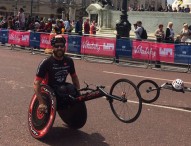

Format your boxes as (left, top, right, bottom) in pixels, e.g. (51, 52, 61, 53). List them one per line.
(58, 102, 87, 129)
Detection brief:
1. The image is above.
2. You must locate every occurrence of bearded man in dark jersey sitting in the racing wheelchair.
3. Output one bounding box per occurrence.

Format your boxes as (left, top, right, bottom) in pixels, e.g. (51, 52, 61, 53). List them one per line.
(34, 35, 80, 112)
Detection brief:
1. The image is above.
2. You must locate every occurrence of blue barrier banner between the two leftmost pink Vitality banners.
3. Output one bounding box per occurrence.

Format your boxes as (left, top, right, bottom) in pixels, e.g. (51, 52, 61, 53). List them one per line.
(30, 32, 40, 48)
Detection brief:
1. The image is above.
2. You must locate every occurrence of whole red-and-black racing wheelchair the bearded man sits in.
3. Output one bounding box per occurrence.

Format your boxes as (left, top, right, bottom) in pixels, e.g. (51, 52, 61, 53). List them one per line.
(28, 79, 142, 139)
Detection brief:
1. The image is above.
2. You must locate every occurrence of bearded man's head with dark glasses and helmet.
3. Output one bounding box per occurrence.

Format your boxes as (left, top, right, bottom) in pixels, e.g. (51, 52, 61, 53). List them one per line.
(51, 35, 66, 58)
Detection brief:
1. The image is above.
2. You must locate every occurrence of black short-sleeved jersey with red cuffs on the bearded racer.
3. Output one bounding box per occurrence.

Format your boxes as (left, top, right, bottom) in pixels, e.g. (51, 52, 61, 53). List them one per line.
(36, 56, 76, 87)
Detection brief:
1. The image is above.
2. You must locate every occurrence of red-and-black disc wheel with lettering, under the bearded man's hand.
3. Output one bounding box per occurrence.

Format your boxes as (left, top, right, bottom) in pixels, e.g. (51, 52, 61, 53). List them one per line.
(28, 85, 56, 139)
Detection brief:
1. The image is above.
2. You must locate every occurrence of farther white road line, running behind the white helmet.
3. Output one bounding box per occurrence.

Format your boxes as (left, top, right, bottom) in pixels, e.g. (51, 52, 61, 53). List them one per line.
(103, 71, 191, 84)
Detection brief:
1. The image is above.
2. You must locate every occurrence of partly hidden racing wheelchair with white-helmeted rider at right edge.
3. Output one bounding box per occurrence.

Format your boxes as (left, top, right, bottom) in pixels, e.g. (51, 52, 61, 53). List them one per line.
(137, 79, 188, 103)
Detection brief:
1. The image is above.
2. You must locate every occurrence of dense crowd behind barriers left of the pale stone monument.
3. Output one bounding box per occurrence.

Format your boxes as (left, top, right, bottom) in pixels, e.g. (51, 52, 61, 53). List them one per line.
(0, 8, 97, 35)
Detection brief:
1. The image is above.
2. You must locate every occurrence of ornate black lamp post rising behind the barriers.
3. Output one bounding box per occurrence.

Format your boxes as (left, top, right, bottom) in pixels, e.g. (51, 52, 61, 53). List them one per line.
(116, 0, 131, 39)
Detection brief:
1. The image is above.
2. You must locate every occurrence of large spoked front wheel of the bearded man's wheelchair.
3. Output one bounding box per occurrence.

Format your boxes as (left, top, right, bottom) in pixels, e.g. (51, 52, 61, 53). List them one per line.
(109, 79, 142, 123)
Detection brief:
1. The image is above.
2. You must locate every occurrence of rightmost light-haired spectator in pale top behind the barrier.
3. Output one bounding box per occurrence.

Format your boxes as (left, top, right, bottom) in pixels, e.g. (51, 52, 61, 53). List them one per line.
(180, 23, 191, 42)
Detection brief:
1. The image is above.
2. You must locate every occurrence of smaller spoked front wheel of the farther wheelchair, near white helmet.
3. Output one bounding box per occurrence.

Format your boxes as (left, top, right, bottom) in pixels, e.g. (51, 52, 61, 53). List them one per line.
(137, 80, 160, 103)
